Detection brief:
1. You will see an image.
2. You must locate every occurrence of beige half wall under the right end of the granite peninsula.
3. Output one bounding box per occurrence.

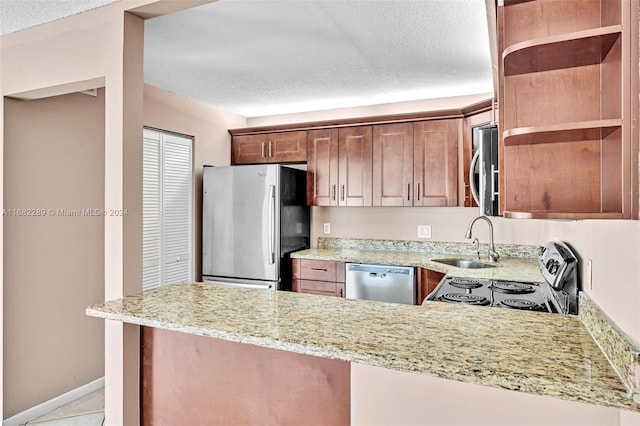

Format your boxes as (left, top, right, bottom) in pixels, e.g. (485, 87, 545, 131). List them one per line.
(351, 363, 640, 426)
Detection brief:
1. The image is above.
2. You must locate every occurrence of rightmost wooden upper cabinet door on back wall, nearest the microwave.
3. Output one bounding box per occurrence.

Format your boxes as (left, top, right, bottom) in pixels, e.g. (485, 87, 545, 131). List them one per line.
(413, 119, 459, 206)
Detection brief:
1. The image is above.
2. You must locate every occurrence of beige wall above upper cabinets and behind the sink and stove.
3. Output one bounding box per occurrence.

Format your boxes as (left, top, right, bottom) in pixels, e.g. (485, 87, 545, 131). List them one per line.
(247, 100, 640, 342)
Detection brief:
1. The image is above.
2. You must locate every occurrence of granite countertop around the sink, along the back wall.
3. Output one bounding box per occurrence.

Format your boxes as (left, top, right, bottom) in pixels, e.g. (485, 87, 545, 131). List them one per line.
(291, 248, 544, 282)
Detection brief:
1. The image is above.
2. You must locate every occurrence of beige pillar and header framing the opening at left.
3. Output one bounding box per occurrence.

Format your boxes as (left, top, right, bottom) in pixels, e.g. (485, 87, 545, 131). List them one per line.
(0, 0, 202, 425)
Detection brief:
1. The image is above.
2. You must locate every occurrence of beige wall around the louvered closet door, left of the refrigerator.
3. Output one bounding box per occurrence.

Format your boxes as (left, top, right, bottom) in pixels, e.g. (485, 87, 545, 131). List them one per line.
(144, 84, 246, 280)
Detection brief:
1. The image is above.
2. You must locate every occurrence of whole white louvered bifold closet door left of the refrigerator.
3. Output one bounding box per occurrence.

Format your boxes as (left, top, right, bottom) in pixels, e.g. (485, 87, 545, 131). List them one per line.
(142, 129, 193, 289)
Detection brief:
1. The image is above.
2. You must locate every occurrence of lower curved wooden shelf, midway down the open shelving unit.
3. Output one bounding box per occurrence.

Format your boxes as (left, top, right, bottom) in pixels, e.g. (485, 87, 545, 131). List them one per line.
(502, 119, 622, 146)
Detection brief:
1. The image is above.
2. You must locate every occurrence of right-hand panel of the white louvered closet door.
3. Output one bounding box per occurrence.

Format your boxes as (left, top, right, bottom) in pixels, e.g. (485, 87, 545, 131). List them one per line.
(162, 134, 192, 284)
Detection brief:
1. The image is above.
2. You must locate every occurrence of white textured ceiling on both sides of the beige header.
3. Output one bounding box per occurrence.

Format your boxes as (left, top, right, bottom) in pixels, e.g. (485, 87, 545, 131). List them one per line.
(0, 0, 493, 117)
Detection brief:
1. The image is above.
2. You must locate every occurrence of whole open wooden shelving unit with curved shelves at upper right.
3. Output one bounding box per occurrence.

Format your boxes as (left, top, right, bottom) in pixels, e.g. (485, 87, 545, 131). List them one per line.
(499, 0, 637, 219)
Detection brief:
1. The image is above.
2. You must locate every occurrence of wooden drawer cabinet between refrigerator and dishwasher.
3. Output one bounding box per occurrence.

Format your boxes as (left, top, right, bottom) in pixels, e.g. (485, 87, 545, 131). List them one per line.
(292, 259, 345, 297)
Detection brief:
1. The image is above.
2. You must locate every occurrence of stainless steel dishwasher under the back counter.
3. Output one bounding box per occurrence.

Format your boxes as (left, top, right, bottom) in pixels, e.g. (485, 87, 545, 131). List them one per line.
(345, 263, 416, 305)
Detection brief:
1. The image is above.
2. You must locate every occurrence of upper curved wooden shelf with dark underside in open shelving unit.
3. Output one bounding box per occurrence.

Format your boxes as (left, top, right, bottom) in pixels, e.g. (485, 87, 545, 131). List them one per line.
(502, 25, 622, 76)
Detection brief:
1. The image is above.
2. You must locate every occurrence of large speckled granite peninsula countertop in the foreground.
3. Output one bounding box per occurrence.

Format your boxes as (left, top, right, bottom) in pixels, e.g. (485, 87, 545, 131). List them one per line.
(87, 283, 640, 411)
